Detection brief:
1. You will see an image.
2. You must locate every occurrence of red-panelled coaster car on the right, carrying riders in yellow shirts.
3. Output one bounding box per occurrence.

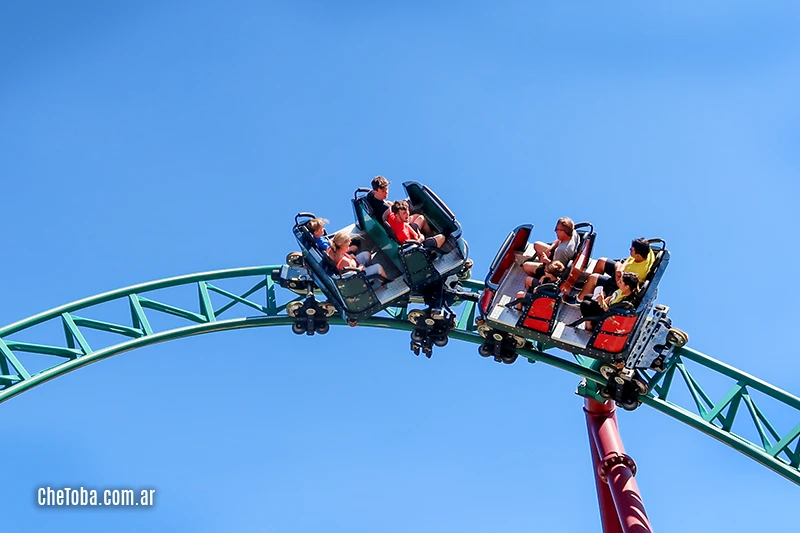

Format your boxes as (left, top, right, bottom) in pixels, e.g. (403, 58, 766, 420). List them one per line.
(478, 223, 688, 394)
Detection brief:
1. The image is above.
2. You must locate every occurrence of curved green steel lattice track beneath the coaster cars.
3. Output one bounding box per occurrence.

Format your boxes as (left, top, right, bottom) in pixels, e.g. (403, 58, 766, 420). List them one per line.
(0, 265, 800, 485)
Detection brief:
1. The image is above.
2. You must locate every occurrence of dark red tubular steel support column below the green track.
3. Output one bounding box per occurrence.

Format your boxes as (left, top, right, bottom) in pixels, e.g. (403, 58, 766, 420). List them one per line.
(583, 398, 653, 533)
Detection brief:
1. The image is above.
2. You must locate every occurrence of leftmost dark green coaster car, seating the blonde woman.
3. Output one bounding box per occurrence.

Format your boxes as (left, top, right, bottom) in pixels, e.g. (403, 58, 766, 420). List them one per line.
(278, 213, 411, 324)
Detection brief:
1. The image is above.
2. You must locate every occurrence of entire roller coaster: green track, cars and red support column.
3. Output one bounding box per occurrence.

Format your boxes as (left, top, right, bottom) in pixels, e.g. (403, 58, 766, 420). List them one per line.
(0, 182, 800, 532)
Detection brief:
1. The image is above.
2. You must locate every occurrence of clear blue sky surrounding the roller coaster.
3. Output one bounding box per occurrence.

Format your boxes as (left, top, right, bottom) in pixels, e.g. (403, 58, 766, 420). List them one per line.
(0, 0, 800, 533)
